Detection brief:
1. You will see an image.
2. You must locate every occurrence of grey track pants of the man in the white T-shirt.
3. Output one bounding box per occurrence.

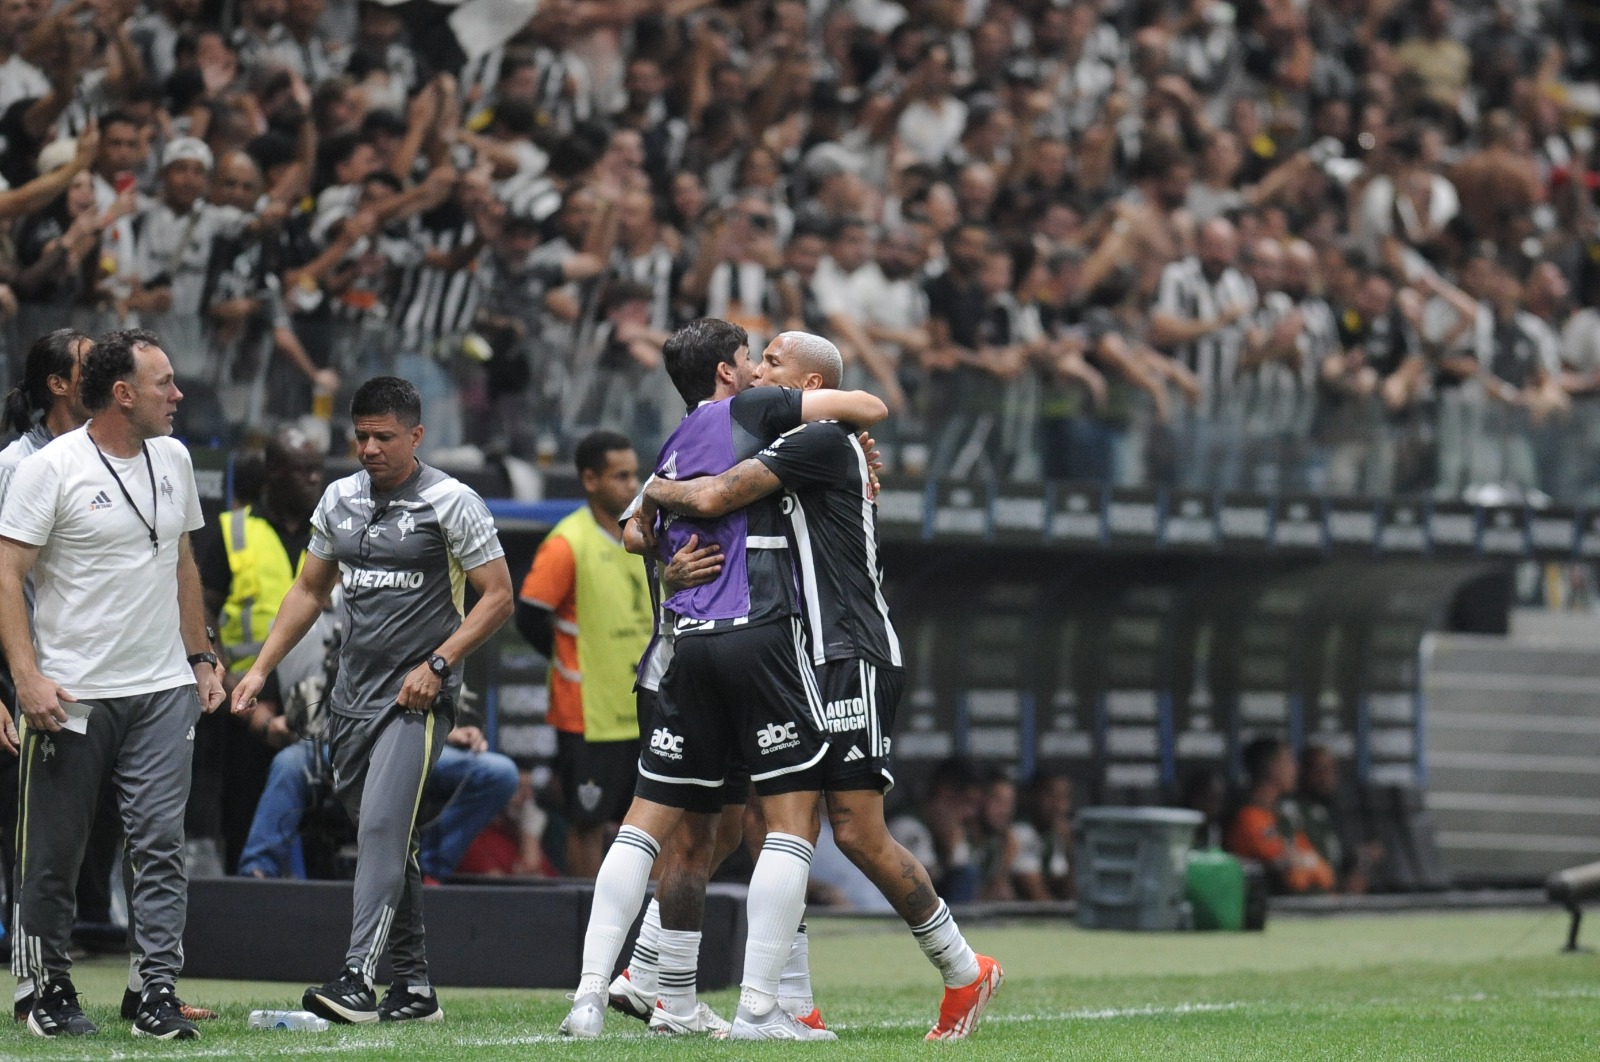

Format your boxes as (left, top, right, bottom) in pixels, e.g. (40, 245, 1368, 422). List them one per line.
(11, 686, 200, 987)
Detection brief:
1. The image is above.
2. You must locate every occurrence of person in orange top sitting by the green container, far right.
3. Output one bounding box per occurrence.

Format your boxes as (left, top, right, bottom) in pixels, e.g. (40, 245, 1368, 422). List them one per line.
(1227, 737, 1336, 892)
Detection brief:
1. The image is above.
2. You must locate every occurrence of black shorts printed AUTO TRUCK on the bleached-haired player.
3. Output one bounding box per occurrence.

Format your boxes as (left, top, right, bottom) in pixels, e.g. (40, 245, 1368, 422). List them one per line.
(816, 661, 906, 793)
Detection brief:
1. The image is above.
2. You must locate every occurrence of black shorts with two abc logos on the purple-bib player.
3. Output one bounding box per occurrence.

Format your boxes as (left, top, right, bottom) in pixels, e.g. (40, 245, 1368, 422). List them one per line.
(638, 617, 829, 809)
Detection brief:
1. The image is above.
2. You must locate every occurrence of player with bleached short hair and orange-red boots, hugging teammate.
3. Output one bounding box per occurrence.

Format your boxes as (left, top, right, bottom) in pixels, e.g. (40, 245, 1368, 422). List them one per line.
(646, 333, 1003, 1040)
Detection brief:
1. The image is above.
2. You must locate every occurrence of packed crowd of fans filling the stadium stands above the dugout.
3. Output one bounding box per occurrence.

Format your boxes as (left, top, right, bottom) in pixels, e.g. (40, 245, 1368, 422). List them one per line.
(0, 0, 1600, 501)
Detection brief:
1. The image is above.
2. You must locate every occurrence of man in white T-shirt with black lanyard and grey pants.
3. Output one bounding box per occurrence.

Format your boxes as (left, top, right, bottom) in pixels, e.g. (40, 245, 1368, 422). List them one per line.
(0, 331, 222, 1040)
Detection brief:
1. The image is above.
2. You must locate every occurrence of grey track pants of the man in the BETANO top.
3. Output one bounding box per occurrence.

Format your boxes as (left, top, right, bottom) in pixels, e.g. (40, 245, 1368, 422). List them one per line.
(328, 707, 451, 985)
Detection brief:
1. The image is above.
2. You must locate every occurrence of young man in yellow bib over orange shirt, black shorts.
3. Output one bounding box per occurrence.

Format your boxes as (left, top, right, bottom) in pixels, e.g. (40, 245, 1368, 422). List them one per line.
(515, 430, 651, 878)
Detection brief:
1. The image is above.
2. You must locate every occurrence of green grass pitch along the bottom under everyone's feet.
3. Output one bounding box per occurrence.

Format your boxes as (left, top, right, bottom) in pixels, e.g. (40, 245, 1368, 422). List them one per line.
(9, 912, 1600, 1062)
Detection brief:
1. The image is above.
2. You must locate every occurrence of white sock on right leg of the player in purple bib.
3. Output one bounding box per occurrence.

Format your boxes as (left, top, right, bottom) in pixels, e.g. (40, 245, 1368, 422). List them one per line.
(739, 833, 813, 1017)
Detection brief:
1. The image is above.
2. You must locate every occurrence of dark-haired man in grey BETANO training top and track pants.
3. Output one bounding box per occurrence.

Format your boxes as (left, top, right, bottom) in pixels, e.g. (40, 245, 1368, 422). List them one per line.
(234, 376, 512, 1022)
